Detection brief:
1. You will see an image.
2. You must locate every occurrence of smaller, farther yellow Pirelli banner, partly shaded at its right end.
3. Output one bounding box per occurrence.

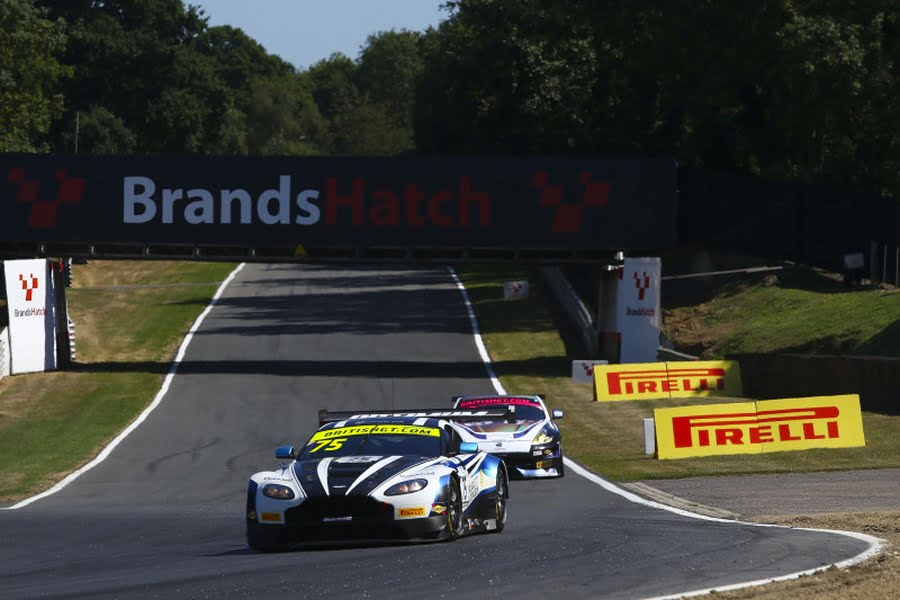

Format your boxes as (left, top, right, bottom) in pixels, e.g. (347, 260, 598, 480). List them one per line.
(594, 360, 742, 402)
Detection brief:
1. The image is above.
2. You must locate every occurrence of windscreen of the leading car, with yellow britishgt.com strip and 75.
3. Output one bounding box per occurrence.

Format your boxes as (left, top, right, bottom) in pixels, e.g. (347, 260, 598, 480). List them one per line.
(300, 424, 442, 460)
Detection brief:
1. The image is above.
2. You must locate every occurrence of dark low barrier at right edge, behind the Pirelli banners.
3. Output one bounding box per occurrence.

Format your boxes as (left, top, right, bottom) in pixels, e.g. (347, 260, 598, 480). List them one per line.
(728, 354, 900, 414)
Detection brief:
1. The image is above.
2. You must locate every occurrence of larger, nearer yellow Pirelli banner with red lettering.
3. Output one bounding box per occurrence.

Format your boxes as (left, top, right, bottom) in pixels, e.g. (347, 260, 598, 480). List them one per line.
(653, 394, 866, 459)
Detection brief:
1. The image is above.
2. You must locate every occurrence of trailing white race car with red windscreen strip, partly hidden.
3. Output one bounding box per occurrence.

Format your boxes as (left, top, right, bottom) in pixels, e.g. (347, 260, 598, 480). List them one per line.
(453, 395, 565, 478)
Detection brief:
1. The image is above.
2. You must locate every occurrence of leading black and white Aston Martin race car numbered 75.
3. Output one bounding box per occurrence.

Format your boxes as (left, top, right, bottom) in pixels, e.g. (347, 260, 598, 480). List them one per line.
(246, 410, 509, 551)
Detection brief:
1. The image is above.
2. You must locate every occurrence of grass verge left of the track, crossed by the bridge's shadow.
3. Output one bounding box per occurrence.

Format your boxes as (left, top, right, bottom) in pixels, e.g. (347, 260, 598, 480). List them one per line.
(0, 261, 234, 504)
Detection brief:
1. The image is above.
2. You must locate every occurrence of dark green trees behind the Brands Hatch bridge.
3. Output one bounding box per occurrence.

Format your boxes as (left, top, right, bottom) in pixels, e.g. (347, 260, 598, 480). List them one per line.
(0, 0, 900, 196)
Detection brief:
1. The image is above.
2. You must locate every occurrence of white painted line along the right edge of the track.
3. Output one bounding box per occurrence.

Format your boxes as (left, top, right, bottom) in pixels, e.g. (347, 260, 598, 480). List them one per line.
(447, 267, 887, 600)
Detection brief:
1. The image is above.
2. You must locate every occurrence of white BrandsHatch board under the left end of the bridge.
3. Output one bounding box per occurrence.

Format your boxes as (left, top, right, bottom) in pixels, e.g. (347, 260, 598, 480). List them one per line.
(3, 259, 57, 375)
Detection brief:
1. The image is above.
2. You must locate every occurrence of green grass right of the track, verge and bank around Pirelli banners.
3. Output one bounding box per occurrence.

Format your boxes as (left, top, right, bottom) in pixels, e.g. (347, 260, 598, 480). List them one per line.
(458, 265, 900, 481)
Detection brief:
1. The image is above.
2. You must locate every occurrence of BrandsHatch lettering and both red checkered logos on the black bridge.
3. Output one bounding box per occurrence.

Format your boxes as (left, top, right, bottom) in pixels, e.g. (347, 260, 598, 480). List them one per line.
(7, 167, 612, 234)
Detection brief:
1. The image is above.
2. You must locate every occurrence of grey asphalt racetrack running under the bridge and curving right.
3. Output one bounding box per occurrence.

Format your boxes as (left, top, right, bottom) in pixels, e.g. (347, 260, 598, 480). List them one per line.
(0, 265, 868, 600)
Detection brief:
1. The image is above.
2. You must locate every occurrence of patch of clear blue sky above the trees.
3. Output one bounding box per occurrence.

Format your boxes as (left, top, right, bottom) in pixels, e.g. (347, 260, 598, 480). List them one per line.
(191, 0, 447, 70)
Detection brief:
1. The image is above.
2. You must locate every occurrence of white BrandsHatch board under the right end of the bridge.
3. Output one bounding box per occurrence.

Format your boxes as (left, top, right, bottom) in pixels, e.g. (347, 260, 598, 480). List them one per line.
(616, 257, 661, 363)
